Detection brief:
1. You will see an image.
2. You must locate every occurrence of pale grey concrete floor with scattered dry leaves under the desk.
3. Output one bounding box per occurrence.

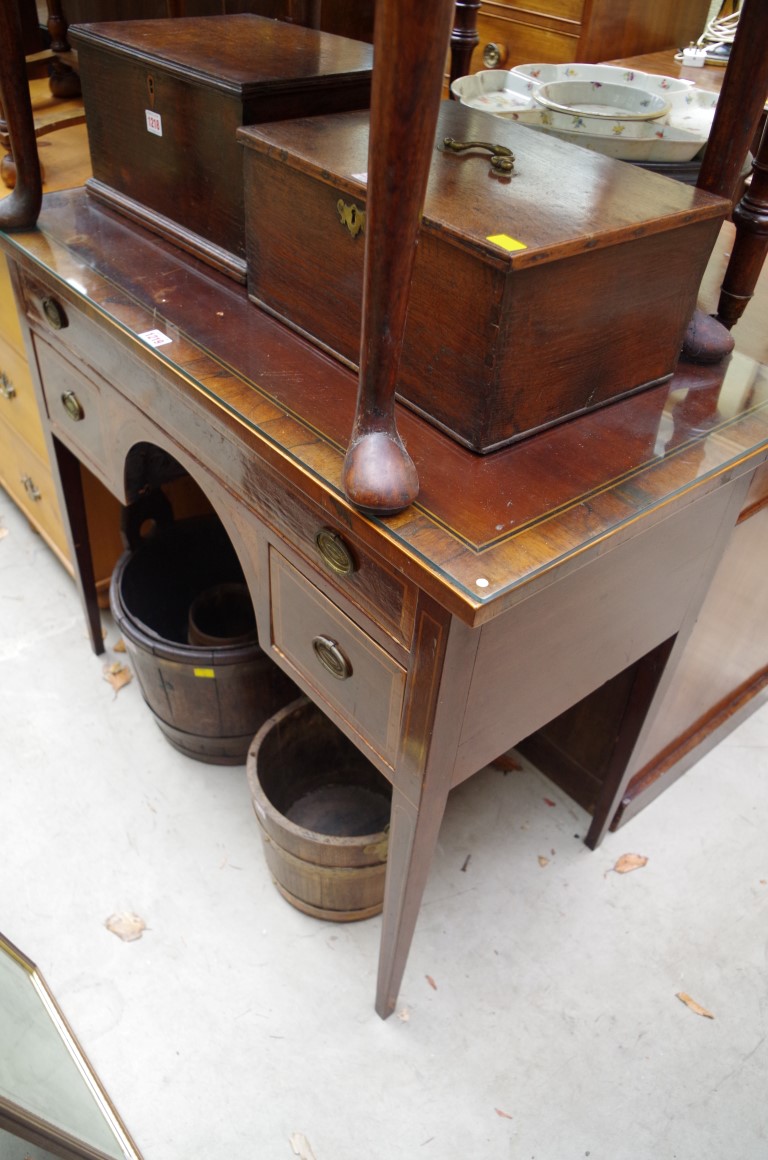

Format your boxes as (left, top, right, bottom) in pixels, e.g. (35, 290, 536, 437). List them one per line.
(0, 492, 768, 1160)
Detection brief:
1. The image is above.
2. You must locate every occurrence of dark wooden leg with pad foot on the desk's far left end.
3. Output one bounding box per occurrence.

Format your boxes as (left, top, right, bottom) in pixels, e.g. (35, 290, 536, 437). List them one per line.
(0, 3, 43, 230)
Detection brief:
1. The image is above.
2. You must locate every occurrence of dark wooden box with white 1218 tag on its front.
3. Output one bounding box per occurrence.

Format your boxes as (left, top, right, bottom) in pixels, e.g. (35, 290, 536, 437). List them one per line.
(70, 14, 372, 281)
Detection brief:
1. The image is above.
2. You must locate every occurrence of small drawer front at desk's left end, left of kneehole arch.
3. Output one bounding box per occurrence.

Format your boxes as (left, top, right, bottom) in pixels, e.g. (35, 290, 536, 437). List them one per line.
(34, 336, 106, 471)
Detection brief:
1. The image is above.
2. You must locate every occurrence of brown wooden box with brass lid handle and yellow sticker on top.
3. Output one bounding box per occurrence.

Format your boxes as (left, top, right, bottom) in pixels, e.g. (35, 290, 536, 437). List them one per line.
(238, 102, 730, 452)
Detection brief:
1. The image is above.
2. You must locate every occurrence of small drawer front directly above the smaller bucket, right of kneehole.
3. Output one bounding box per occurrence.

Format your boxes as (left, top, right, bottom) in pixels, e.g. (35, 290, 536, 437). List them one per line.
(269, 549, 406, 766)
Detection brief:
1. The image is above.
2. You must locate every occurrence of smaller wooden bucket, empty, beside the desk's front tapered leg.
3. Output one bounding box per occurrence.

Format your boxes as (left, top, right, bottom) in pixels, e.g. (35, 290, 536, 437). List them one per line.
(246, 697, 392, 922)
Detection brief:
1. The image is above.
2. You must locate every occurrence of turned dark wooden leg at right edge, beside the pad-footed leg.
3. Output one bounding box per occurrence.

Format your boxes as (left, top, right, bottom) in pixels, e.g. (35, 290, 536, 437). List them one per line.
(717, 125, 768, 331)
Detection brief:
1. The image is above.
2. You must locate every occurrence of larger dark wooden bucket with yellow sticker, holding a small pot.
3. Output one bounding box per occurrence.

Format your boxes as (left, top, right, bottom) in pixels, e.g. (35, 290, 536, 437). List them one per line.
(109, 516, 298, 766)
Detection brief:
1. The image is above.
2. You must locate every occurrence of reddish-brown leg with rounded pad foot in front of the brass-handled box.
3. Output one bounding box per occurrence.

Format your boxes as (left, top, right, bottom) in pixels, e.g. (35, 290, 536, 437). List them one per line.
(343, 0, 454, 515)
